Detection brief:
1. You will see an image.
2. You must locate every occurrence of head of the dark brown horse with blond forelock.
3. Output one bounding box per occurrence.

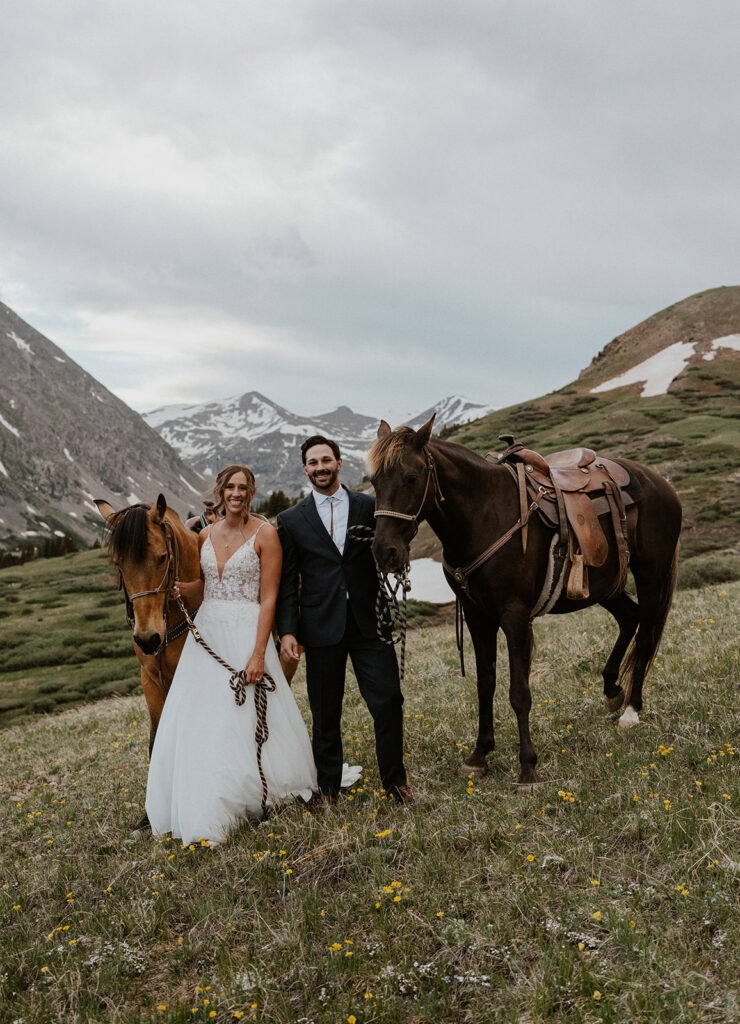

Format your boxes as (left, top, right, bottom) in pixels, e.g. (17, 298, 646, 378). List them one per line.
(367, 416, 436, 572)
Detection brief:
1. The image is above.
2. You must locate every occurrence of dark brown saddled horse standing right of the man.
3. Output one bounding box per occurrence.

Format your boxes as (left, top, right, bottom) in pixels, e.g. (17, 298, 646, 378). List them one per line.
(367, 417, 681, 784)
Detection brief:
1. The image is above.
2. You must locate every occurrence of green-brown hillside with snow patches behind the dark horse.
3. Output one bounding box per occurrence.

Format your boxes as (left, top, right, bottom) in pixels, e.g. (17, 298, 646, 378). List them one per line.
(438, 287, 740, 586)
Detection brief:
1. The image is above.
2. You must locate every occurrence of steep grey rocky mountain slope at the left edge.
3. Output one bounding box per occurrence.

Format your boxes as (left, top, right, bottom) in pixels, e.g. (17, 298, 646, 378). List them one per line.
(0, 303, 207, 547)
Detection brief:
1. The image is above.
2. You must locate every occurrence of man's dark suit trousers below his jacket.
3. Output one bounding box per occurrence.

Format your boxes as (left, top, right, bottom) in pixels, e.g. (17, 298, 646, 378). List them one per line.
(306, 606, 406, 796)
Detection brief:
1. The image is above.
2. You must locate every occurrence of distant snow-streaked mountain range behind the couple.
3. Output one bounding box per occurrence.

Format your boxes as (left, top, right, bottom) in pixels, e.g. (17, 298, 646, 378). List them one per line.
(143, 391, 491, 497)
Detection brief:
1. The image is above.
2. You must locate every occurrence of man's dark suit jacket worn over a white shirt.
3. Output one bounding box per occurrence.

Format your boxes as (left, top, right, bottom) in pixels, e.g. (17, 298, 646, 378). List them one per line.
(275, 487, 378, 647)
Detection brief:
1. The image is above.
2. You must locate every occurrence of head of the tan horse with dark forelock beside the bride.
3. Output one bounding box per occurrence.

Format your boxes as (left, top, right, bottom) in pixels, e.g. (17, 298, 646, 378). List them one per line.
(95, 495, 177, 654)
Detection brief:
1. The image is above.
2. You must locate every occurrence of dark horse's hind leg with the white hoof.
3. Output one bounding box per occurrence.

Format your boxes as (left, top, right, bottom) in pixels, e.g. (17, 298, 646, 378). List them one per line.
(619, 544, 679, 729)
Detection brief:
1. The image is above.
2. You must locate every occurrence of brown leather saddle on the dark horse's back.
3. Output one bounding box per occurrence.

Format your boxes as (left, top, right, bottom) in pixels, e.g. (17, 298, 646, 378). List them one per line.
(488, 434, 634, 600)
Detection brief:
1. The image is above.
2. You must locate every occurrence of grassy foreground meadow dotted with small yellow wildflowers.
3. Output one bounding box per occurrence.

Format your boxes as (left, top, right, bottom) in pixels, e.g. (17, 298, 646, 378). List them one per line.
(0, 581, 740, 1024)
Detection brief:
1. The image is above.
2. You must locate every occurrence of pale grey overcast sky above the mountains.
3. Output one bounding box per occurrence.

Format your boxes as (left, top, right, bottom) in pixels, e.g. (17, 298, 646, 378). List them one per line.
(0, 0, 740, 414)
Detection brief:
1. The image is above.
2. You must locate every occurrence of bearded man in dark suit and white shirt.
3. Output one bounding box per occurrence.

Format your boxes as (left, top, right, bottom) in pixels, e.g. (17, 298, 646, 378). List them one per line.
(275, 434, 412, 803)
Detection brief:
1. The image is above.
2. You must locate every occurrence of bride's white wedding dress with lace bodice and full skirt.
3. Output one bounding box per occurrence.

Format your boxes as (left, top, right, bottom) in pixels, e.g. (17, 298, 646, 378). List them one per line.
(146, 527, 347, 845)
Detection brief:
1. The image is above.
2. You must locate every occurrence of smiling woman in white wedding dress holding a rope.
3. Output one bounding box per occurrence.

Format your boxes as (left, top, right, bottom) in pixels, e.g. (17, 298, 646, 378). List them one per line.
(146, 466, 335, 845)
